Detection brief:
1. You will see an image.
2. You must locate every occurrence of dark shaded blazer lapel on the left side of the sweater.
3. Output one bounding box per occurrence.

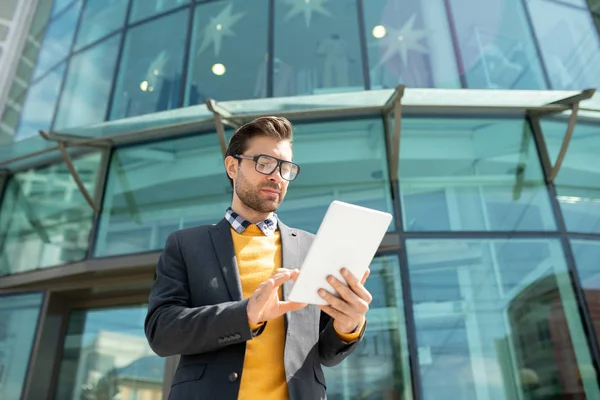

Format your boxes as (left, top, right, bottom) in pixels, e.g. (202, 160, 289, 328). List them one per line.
(210, 218, 242, 301)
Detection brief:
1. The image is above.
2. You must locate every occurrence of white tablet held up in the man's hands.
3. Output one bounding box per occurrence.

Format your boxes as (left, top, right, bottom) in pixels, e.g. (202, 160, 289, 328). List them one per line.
(287, 200, 393, 305)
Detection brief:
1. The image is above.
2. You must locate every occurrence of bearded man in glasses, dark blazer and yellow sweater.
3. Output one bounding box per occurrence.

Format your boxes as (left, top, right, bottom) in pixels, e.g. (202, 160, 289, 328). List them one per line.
(145, 117, 372, 400)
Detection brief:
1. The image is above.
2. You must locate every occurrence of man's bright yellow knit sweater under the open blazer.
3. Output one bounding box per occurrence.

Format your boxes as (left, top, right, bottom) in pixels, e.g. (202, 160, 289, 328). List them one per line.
(231, 225, 364, 400)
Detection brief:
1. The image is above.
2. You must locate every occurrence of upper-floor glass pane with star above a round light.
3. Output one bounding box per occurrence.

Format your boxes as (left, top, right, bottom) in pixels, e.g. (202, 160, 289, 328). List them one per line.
(185, 0, 266, 104)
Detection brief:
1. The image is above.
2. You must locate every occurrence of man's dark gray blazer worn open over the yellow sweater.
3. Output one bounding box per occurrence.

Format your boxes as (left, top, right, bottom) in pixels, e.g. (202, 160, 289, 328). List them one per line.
(144, 219, 364, 400)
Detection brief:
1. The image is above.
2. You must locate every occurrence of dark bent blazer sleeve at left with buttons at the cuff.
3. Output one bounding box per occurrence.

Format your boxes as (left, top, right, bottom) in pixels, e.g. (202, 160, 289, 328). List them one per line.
(144, 232, 265, 357)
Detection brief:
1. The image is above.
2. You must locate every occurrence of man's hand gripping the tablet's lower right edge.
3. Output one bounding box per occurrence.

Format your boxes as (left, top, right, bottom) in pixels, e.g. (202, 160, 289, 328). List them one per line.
(319, 268, 373, 334)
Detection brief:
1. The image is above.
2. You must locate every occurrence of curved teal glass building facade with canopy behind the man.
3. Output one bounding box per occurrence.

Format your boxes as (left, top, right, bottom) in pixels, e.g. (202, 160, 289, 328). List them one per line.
(0, 0, 600, 400)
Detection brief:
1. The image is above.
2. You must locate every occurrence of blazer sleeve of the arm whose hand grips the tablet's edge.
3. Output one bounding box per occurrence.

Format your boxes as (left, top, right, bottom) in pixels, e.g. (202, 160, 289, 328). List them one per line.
(319, 304, 366, 367)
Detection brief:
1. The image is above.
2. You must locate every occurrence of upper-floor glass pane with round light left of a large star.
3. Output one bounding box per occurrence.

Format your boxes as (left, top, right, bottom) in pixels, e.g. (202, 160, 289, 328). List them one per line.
(364, 0, 460, 89)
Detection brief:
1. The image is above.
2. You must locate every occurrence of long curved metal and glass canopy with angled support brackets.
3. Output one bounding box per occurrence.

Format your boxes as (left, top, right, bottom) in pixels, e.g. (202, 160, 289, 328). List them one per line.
(0, 85, 600, 205)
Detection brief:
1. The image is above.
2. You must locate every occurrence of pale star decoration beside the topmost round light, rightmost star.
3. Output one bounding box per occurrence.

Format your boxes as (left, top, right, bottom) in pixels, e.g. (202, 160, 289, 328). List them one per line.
(374, 14, 429, 65)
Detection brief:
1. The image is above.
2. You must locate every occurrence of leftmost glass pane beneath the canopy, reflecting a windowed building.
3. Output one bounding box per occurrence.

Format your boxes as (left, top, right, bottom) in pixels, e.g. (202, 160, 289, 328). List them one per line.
(0, 154, 100, 275)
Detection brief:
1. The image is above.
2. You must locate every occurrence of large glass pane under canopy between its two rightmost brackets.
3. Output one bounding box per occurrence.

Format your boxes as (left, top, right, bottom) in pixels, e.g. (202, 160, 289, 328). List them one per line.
(399, 118, 556, 231)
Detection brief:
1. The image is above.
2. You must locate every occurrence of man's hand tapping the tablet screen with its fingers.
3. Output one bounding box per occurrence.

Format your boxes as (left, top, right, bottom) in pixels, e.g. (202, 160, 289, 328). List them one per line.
(246, 268, 307, 325)
